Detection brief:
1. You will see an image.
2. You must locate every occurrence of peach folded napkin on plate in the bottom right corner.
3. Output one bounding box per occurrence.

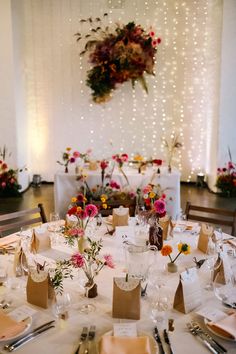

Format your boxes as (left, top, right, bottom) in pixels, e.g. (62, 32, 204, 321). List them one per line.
(207, 312, 236, 339)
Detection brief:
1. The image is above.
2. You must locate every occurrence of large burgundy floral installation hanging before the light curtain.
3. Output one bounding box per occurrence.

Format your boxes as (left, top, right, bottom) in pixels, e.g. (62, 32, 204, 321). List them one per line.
(76, 14, 161, 103)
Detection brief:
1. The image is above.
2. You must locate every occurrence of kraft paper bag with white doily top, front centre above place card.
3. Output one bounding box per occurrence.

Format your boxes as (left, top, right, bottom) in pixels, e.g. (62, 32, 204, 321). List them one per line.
(112, 278, 141, 320)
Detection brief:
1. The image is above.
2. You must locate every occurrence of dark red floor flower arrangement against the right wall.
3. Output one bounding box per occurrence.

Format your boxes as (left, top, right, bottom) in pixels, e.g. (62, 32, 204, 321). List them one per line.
(216, 150, 236, 197)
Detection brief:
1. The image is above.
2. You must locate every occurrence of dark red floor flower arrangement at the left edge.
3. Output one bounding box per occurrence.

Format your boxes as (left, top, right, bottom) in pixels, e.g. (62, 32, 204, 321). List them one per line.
(0, 146, 21, 197)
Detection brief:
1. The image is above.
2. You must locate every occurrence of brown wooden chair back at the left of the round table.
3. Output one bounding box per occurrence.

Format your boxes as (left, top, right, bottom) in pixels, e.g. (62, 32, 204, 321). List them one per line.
(0, 204, 47, 236)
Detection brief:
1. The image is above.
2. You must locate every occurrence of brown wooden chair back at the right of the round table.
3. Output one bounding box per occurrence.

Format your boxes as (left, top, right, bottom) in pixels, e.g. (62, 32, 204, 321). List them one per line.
(185, 202, 236, 236)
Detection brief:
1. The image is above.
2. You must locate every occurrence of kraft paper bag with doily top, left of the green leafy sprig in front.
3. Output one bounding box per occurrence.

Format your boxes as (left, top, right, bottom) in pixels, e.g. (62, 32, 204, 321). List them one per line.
(26, 270, 55, 309)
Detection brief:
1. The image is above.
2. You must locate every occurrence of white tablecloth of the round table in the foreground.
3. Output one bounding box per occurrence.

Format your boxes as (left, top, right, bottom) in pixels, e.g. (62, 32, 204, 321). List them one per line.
(0, 225, 236, 354)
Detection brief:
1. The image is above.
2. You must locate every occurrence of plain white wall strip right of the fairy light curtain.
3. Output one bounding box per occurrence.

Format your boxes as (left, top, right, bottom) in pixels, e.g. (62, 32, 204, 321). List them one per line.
(218, 0, 236, 167)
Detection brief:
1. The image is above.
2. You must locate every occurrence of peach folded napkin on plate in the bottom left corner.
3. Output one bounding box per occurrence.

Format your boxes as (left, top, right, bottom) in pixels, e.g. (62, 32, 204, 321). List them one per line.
(0, 311, 26, 340)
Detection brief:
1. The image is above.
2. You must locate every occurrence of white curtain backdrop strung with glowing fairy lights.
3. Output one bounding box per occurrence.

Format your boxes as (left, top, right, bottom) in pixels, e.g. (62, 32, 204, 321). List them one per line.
(22, 0, 222, 181)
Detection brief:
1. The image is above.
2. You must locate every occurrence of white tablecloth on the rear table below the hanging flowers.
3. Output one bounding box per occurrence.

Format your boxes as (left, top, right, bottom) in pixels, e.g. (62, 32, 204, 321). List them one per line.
(54, 167, 180, 218)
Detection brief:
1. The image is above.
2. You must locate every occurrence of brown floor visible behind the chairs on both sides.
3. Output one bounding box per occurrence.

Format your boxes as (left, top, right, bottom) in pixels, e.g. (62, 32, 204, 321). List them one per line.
(0, 183, 236, 219)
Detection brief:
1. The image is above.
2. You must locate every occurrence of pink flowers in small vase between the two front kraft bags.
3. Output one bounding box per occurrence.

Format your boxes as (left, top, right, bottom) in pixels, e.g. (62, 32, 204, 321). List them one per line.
(70, 237, 115, 297)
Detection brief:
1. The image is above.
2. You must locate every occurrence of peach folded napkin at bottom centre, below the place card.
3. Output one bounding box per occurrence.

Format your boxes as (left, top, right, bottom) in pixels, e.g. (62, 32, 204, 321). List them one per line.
(99, 335, 152, 354)
